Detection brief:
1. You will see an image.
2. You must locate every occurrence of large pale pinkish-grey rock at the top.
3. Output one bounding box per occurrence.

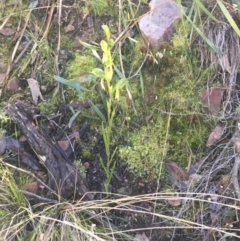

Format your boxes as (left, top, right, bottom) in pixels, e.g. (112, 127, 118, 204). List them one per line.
(139, 0, 185, 49)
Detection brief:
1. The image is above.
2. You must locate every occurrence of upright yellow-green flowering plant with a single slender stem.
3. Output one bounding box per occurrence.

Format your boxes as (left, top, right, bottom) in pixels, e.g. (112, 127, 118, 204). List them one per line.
(89, 25, 128, 192)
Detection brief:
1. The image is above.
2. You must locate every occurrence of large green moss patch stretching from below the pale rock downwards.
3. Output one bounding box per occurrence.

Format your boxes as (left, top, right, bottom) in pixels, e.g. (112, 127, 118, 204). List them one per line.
(119, 20, 211, 179)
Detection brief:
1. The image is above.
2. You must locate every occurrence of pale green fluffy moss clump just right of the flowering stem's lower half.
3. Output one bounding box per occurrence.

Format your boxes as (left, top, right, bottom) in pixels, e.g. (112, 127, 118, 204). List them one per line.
(119, 118, 169, 178)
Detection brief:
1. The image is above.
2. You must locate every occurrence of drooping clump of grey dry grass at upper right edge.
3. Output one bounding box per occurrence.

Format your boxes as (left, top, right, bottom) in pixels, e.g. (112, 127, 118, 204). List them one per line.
(200, 1, 240, 116)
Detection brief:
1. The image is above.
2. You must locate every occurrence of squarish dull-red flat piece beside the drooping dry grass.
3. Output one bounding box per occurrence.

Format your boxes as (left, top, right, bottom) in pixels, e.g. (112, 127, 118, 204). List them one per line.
(201, 87, 225, 114)
